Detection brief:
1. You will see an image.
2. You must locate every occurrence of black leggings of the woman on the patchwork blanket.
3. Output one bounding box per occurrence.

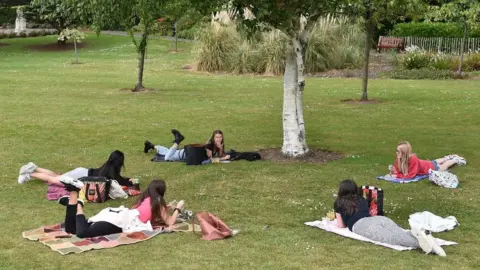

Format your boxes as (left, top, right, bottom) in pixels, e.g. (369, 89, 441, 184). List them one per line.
(65, 205, 122, 238)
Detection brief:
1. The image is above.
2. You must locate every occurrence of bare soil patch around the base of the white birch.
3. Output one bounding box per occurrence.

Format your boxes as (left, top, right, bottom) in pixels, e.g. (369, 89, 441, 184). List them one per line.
(258, 148, 345, 164)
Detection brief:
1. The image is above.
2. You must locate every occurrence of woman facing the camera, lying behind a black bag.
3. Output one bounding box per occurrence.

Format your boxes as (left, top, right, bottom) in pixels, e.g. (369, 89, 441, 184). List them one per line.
(143, 129, 230, 161)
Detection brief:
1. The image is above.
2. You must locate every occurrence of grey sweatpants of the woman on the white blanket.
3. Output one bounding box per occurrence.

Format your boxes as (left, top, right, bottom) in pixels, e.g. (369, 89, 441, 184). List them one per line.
(352, 216, 419, 248)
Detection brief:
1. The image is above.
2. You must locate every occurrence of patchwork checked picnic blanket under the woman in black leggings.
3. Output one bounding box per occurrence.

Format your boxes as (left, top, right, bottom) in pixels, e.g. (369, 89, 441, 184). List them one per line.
(22, 222, 200, 255)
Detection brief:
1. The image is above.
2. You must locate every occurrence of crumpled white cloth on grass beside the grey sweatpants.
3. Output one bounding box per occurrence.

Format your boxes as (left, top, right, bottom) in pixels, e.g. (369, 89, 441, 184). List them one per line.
(408, 211, 460, 232)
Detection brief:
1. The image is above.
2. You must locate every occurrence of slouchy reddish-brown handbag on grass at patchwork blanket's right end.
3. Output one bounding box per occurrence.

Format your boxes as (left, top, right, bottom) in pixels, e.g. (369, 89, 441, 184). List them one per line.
(192, 212, 232, 240)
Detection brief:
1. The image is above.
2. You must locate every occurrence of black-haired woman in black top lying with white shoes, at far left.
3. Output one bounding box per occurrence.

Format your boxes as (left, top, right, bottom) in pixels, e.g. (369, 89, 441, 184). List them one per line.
(18, 150, 134, 186)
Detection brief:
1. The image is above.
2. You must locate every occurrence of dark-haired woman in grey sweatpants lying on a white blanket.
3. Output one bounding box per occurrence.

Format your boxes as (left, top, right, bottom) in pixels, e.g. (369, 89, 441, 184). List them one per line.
(334, 180, 446, 256)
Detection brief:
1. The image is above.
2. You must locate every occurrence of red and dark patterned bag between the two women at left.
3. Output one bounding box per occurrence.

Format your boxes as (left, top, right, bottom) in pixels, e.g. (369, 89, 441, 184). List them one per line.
(78, 176, 111, 203)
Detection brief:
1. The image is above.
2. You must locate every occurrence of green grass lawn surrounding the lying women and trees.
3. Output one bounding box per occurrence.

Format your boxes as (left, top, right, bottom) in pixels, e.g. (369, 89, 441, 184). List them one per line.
(0, 34, 480, 269)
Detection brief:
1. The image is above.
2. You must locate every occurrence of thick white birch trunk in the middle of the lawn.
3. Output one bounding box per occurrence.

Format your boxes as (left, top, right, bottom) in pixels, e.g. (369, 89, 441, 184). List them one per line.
(282, 36, 309, 157)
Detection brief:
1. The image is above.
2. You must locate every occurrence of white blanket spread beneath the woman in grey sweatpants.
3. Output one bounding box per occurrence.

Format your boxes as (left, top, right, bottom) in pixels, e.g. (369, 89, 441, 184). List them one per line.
(305, 220, 457, 251)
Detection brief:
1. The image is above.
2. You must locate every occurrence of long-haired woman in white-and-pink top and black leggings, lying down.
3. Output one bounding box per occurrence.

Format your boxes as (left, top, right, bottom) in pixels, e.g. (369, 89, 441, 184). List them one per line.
(58, 179, 184, 238)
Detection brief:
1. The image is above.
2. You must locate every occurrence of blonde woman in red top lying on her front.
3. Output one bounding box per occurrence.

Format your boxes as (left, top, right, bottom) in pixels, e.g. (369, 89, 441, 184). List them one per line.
(389, 142, 467, 178)
